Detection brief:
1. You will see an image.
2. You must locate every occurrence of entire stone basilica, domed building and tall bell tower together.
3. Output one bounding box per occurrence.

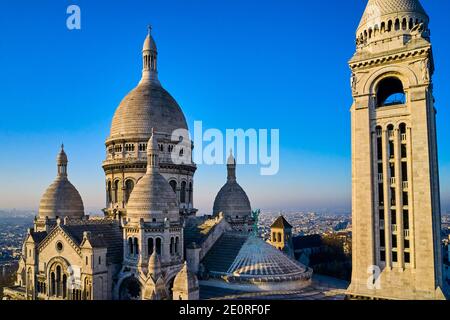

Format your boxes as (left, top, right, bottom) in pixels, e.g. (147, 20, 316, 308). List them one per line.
(4, 0, 450, 300)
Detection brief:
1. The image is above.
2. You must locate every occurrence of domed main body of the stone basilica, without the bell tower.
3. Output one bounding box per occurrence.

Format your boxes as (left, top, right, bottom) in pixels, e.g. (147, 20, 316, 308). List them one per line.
(4, 30, 312, 300)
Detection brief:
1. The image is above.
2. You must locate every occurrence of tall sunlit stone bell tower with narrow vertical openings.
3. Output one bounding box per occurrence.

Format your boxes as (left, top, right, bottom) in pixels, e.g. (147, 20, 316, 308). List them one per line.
(348, 0, 445, 299)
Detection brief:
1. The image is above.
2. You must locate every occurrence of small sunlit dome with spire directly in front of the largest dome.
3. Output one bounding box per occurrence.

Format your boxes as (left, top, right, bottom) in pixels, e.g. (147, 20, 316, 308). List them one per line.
(127, 134, 179, 222)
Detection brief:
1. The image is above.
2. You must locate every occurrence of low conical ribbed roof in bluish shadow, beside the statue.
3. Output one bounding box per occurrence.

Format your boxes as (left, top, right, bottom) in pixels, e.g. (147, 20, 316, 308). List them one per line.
(221, 235, 312, 282)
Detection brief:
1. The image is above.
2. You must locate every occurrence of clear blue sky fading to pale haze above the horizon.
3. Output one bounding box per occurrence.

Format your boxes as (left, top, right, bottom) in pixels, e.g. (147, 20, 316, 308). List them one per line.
(0, 0, 450, 213)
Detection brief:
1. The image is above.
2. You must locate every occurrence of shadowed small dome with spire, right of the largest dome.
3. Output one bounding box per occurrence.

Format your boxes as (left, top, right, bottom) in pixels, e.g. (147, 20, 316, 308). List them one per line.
(213, 154, 252, 219)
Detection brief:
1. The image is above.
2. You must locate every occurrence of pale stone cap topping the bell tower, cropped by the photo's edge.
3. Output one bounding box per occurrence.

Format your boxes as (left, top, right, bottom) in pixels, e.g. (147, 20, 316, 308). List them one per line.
(358, 0, 427, 29)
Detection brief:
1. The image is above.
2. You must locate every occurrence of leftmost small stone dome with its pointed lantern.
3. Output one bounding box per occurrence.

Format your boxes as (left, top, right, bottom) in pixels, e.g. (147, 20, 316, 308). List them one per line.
(39, 146, 84, 219)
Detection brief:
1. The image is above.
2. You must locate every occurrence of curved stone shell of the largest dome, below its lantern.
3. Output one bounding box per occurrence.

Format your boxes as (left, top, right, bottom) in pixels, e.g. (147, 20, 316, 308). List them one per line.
(110, 82, 188, 138)
